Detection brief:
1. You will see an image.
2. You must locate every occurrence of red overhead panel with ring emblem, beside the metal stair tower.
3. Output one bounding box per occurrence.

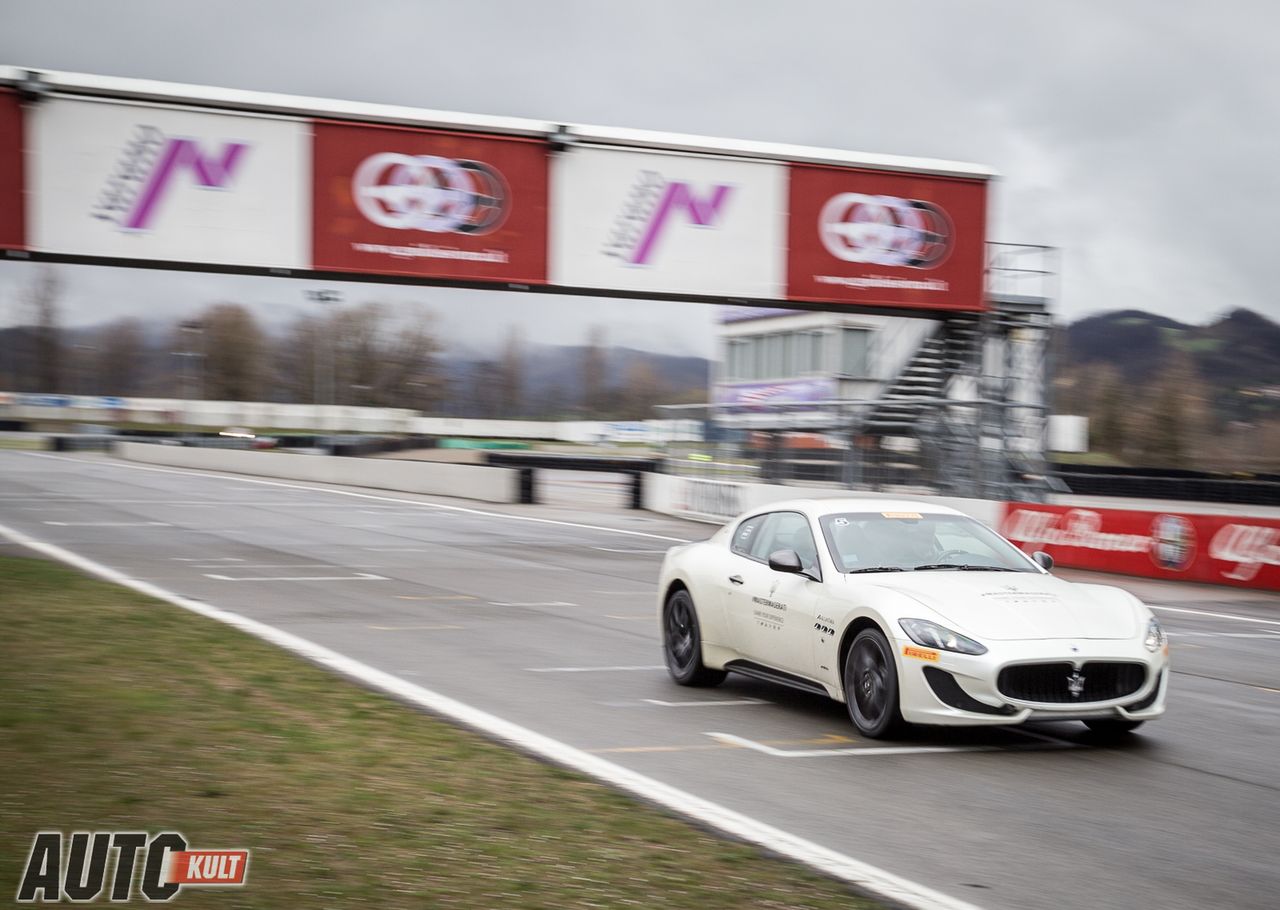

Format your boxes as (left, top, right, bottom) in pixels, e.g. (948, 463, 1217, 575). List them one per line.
(786, 164, 987, 310)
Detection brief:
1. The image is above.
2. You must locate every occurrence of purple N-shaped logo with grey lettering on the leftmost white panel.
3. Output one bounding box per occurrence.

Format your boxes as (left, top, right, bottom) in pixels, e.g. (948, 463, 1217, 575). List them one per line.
(93, 127, 248, 230)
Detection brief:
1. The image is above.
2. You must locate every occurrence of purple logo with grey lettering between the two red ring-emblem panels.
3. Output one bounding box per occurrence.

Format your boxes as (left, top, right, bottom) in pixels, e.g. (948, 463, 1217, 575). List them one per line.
(604, 170, 733, 265)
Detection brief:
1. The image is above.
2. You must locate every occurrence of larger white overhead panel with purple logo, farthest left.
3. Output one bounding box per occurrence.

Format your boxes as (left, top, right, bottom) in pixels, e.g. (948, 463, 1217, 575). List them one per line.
(28, 99, 311, 269)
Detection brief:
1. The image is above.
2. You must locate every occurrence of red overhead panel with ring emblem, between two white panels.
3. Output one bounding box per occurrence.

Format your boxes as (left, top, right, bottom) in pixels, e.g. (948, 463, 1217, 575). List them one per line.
(312, 122, 548, 284)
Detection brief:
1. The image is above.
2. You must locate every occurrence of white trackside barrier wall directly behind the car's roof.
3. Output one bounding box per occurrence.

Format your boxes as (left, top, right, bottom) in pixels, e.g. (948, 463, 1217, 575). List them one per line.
(644, 474, 1004, 527)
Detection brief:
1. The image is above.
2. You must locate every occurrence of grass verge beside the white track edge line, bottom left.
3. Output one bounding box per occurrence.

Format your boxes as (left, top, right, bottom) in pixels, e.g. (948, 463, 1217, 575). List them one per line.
(0, 557, 877, 910)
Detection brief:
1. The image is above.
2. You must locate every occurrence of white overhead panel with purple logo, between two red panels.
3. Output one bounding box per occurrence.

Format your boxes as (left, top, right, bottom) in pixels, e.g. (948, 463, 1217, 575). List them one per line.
(549, 147, 787, 298)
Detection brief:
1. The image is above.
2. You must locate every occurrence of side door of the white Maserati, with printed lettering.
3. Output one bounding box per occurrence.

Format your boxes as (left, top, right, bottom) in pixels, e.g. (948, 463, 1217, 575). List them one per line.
(726, 512, 822, 677)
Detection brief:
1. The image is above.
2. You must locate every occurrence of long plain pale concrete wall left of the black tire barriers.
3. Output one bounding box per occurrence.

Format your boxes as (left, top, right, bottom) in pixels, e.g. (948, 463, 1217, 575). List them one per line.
(115, 443, 520, 503)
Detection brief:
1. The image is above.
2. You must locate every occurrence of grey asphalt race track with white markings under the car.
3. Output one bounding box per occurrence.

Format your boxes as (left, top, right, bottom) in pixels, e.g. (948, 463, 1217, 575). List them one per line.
(0, 452, 1280, 910)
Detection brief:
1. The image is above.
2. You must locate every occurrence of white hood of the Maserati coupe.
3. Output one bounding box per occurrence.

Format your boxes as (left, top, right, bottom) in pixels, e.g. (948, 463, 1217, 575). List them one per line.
(874, 571, 1139, 641)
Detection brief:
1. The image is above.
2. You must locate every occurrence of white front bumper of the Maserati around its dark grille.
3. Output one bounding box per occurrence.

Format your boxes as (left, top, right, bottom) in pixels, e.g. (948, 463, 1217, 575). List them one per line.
(896, 639, 1169, 726)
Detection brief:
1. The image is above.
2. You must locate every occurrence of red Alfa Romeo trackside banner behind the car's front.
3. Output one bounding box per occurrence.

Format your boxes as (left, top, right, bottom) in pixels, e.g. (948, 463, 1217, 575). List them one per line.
(1001, 503, 1280, 590)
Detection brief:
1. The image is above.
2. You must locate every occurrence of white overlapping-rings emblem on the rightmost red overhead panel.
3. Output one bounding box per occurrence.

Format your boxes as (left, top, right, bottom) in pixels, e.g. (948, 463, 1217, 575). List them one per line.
(818, 193, 951, 269)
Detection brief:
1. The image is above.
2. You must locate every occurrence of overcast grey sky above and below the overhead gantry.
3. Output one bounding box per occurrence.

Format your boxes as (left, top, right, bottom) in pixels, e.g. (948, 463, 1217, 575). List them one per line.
(0, 0, 1280, 353)
